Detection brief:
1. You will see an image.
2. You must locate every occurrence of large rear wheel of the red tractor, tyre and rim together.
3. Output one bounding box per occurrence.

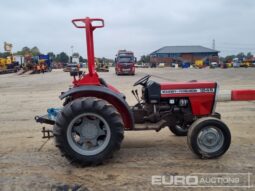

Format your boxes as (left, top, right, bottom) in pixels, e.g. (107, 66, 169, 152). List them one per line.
(53, 97, 124, 166)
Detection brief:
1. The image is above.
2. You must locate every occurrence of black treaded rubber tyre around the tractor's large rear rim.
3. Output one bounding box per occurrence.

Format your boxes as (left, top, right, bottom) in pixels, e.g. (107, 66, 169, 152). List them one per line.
(53, 97, 124, 166)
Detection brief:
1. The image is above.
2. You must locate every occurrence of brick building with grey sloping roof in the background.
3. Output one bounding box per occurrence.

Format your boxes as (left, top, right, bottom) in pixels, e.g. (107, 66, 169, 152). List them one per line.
(150, 46, 219, 66)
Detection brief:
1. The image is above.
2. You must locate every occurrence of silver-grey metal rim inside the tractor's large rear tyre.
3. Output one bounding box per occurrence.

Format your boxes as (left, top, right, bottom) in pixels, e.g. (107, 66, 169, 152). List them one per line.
(67, 113, 111, 156)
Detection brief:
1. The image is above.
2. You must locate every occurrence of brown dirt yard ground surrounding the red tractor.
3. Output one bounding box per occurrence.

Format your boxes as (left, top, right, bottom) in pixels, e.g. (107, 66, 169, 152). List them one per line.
(0, 68, 255, 191)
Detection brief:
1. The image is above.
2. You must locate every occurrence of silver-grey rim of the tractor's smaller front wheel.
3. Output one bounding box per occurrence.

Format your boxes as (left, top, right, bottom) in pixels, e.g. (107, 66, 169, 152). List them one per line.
(197, 127, 224, 153)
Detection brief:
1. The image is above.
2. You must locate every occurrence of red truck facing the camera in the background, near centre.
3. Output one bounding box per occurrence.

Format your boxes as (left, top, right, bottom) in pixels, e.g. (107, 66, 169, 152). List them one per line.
(115, 50, 136, 75)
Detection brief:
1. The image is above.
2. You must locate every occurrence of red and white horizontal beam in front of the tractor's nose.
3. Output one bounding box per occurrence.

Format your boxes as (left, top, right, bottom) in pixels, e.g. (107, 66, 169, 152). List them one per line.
(216, 90, 255, 102)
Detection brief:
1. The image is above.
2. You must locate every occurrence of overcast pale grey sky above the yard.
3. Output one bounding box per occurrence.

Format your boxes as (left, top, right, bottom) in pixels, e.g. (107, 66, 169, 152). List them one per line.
(0, 0, 255, 58)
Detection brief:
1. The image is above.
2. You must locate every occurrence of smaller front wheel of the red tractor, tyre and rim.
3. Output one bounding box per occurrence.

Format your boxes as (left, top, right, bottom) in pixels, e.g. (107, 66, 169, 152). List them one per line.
(187, 117, 231, 159)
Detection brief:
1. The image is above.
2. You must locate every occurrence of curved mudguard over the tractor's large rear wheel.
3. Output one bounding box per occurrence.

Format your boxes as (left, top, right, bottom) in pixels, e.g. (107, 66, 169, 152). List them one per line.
(59, 86, 134, 130)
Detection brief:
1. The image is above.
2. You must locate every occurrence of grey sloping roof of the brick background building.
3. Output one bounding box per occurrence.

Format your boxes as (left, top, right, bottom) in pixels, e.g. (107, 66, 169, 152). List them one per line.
(151, 46, 219, 54)
